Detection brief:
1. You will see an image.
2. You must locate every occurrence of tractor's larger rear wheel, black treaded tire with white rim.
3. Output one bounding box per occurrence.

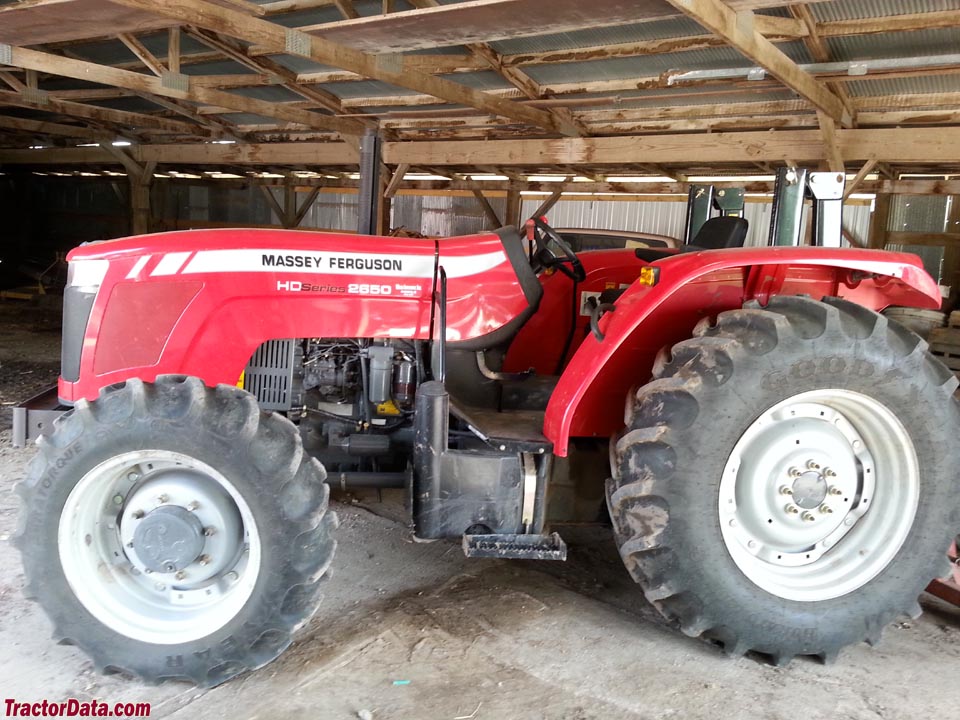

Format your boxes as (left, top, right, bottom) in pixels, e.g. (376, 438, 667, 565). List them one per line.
(607, 297, 960, 664)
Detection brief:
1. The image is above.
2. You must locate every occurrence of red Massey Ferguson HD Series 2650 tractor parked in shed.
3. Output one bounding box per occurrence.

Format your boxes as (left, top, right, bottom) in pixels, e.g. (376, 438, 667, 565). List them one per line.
(16, 173, 960, 686)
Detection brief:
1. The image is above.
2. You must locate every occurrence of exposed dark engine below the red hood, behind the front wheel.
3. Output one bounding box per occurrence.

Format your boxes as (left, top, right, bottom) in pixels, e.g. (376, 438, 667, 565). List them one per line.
(244, 338, 423, 472)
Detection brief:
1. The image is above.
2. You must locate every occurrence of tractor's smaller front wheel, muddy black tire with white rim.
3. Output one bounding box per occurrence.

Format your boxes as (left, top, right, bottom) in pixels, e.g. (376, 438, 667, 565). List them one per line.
(15, 376, 337, 686)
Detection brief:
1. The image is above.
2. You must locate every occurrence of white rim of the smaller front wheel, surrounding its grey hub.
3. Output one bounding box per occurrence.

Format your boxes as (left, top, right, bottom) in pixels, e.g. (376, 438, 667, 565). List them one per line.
(58, 450, 261, 645)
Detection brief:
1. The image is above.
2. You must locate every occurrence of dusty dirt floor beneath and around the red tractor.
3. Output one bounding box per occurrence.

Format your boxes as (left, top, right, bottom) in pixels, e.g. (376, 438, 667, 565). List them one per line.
(0, 304, 960, 720)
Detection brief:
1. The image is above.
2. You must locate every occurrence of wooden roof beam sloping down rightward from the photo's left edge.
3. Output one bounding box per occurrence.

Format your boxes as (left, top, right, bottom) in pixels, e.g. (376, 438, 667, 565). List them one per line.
(4, 43, 364, 134)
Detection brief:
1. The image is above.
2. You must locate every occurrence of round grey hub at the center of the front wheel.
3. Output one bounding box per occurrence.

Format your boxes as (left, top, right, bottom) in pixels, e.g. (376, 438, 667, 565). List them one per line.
(133, 505, 204, 573)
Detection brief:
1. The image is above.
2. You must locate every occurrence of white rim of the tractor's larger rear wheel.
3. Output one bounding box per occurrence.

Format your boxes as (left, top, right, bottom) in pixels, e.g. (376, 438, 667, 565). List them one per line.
(719, 390, 920, 602)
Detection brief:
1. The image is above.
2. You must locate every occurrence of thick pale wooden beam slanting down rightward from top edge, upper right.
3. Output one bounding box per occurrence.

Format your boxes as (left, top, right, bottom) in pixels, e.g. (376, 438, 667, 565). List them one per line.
(667, 0, 852, 125)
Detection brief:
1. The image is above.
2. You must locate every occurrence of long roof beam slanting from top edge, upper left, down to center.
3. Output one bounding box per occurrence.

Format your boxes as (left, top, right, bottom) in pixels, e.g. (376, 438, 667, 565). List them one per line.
(114, 0, 576, 135)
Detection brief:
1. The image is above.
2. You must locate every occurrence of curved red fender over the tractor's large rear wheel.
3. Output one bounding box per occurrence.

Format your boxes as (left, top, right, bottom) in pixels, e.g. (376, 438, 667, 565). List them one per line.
(544, 248, 941, 456)
